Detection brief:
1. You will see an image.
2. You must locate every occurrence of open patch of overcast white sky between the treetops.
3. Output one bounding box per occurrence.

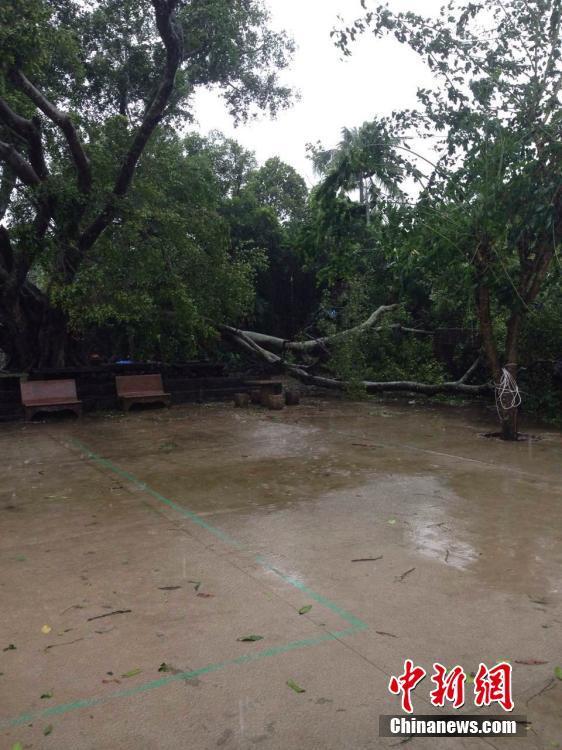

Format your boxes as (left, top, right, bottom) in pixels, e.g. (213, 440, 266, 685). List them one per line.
(191, 0, 443, 185)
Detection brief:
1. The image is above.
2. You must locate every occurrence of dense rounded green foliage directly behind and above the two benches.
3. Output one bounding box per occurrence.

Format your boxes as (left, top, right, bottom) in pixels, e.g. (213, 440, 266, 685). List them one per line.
(53, 135, 261, 359)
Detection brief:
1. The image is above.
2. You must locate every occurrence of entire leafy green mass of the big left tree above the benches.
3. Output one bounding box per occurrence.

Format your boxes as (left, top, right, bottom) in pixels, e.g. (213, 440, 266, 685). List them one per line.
(0, 0, 296, 368)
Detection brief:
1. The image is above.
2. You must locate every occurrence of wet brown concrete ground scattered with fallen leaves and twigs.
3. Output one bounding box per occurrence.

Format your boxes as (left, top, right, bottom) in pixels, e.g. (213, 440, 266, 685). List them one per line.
(0, 400, 562, 750)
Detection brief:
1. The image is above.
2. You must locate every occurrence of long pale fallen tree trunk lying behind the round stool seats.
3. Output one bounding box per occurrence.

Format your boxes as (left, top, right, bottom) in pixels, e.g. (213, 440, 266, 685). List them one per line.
(220, 328, 492, 396)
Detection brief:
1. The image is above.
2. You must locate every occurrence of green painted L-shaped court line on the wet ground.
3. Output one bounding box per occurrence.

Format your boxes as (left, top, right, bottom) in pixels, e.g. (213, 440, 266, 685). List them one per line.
(0, 439, 368, 729)
